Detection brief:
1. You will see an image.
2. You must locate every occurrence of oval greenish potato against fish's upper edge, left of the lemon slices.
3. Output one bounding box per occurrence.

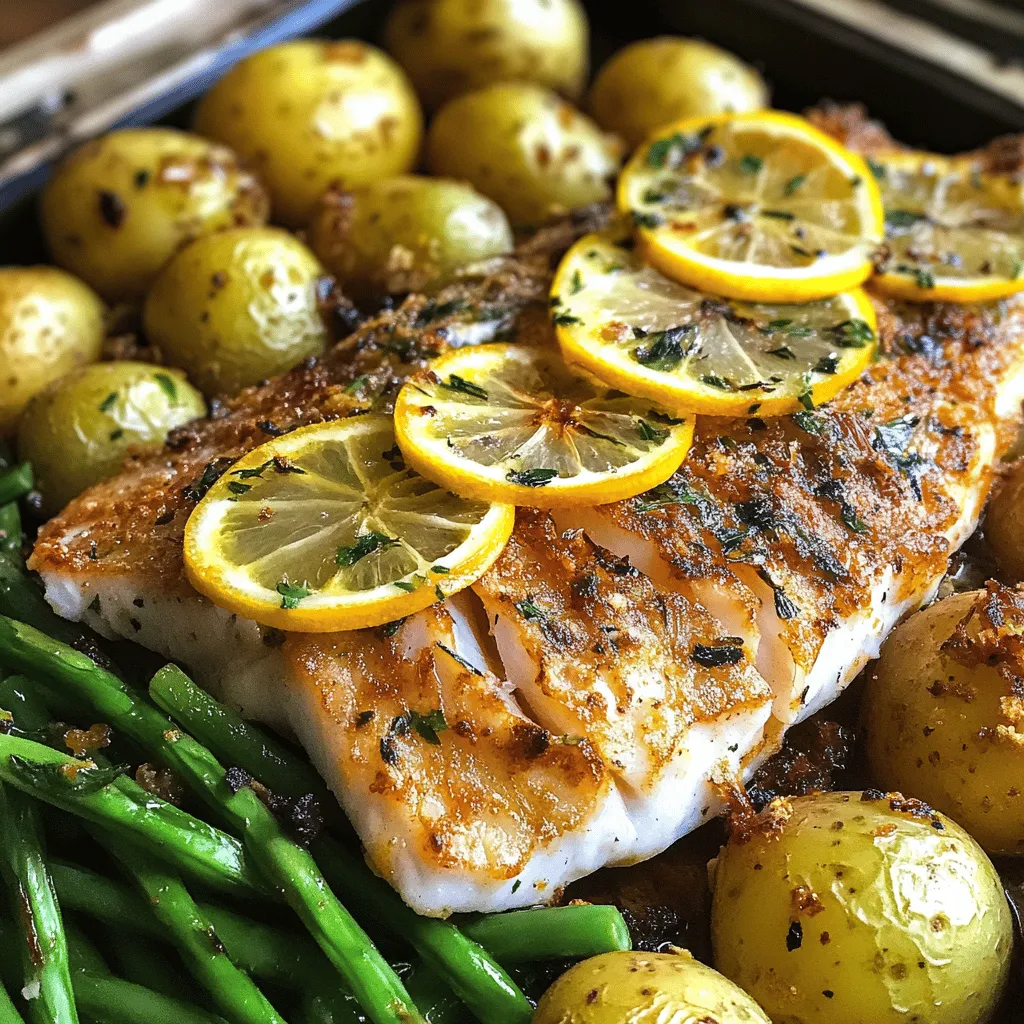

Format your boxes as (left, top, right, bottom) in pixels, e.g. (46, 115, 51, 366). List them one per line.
(309, 175, 513, 299)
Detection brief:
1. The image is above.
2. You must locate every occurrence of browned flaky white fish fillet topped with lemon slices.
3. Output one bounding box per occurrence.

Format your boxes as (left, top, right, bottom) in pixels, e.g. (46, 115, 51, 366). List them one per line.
(31, 111, 1024, 914)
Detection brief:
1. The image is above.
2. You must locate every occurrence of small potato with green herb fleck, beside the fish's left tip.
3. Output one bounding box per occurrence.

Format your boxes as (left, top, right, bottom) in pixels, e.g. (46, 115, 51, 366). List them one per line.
(17, 361, 206, 515)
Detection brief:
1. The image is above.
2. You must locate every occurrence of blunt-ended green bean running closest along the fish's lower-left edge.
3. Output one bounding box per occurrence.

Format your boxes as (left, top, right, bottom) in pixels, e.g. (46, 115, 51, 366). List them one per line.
(150, 670, 531, 1022)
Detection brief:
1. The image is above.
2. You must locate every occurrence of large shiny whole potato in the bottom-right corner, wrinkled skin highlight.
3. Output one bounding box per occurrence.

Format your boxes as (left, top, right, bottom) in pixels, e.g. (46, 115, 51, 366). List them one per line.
(712, 793, 1013, 1024)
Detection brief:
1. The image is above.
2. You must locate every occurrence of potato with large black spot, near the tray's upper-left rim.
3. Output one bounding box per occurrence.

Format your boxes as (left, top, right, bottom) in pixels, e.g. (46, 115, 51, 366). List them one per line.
(40, 128, 269, 301)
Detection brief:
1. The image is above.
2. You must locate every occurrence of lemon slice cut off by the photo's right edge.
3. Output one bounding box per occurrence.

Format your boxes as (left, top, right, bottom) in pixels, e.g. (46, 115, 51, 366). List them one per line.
(871, 153, 1024, 302)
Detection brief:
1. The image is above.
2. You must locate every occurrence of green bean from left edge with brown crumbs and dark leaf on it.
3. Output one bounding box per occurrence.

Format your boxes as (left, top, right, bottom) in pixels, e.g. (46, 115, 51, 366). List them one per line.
(0, 733, 263, 895)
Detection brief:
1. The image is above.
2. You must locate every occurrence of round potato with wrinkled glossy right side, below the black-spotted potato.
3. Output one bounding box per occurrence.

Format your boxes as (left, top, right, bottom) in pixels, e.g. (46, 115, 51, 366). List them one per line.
(142, 227, 327, 395)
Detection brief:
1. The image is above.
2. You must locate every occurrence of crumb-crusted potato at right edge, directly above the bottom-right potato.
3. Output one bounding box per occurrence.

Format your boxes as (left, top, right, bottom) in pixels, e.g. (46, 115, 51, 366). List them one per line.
(862, 592, 1024, 855)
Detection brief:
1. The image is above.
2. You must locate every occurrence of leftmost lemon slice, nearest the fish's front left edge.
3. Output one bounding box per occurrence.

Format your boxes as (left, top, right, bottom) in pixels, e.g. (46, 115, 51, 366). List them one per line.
(184, 414, 515, 633)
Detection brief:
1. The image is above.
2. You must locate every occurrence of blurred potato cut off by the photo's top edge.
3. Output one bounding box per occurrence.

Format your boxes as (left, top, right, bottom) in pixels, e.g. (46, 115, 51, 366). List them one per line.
(384, 0, 590, 109)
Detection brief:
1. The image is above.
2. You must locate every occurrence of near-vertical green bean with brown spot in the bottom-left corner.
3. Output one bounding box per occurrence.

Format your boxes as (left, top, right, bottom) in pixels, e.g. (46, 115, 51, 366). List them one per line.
(0, 785, 78, 1024)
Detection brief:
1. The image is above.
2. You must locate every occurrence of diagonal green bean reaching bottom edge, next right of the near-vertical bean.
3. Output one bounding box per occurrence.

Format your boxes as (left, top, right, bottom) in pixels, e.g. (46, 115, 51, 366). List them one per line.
(94, 834, 284, 1024)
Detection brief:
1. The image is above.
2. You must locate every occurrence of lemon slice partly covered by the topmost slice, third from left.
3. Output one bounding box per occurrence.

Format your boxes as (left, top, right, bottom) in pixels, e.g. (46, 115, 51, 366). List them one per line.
(551, 234, 877, 416)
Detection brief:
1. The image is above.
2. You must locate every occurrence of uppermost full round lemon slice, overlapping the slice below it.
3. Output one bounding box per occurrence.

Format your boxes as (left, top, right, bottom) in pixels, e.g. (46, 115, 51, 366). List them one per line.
(618, 111, 883, 302)
